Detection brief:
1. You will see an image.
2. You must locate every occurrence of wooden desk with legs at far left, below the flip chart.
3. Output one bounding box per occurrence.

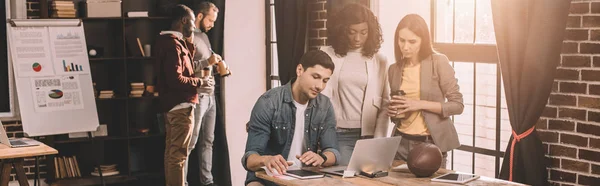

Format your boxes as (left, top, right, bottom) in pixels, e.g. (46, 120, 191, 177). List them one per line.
(0, 143, 58, 186)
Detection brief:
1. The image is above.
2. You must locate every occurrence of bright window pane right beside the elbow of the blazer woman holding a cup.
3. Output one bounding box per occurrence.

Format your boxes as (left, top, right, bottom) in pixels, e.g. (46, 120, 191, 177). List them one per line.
(454, 62, 474, 146)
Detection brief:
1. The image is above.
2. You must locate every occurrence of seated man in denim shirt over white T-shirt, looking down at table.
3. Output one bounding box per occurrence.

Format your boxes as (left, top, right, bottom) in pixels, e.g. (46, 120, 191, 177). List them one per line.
(242, 50, 340, 186)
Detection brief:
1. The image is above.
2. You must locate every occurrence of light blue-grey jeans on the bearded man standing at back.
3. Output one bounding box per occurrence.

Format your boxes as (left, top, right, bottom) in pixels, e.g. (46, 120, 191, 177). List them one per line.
(185, 94, 217, 185)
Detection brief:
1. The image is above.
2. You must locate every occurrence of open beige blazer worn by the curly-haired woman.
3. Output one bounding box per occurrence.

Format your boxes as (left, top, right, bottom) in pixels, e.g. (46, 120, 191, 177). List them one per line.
(321, 46, 391, 137)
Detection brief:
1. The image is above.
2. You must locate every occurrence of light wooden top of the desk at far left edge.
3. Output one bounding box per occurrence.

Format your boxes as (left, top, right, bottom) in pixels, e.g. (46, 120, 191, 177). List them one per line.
(0, 143, 58, 159)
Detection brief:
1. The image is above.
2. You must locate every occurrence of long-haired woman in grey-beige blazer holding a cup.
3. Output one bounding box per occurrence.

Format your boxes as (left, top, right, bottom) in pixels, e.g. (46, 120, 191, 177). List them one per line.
(387, 14, 464, 168)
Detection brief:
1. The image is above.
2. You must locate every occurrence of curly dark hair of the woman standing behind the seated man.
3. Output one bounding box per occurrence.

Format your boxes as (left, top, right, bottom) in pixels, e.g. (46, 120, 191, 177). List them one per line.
(327, 3, 383, 58)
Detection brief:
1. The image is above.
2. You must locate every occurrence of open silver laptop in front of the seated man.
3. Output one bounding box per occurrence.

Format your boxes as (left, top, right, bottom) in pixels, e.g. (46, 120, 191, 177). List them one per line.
(320, 136, 402, 176)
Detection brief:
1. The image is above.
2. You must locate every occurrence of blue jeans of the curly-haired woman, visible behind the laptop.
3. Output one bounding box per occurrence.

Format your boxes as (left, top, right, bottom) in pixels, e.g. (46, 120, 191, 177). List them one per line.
(336, 128, 360, 165)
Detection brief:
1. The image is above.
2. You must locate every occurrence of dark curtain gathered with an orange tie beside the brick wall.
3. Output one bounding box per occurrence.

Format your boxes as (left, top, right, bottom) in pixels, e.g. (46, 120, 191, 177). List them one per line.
(492, 0, 571, 185)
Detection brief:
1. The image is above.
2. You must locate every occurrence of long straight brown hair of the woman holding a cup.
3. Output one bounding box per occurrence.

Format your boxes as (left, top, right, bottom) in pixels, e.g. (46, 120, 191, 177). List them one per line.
(394, 14, 436, 64)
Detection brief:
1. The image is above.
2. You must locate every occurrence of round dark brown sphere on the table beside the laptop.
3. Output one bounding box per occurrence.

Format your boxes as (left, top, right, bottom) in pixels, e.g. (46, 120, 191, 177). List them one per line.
(406, 143, 442, 177)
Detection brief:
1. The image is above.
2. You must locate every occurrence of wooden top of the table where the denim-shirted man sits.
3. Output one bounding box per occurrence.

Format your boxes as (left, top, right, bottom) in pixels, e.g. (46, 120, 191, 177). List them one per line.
(256, 165, 522, 186)
